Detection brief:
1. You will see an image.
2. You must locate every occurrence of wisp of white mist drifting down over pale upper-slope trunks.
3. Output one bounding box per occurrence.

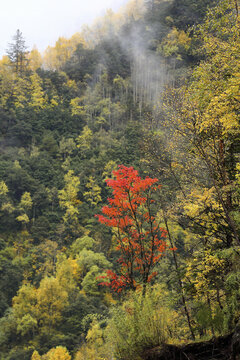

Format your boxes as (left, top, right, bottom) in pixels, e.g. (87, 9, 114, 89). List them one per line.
(86, 4, 172, 108)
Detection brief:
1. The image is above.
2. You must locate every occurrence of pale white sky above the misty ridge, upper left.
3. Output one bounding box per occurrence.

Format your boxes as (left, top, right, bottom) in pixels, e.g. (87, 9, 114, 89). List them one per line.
(0, 0, 128, 57)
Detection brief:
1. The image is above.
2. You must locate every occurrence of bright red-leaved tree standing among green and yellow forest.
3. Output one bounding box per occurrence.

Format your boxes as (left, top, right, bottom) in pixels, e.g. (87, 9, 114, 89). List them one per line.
(97, 165, 171, 292)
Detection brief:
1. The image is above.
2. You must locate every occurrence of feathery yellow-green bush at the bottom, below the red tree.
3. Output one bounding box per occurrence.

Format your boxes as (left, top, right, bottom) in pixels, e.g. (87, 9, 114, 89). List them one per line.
(107, 287, 177, 360)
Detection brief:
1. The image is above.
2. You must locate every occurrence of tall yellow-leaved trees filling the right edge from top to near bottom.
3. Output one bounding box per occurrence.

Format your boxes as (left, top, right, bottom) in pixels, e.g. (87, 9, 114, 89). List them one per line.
(158, 0, 240, 334)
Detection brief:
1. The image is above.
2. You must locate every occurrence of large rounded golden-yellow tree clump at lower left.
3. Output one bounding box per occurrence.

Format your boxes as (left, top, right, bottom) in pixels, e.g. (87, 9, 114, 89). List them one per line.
(12, 270, 73, 339)
